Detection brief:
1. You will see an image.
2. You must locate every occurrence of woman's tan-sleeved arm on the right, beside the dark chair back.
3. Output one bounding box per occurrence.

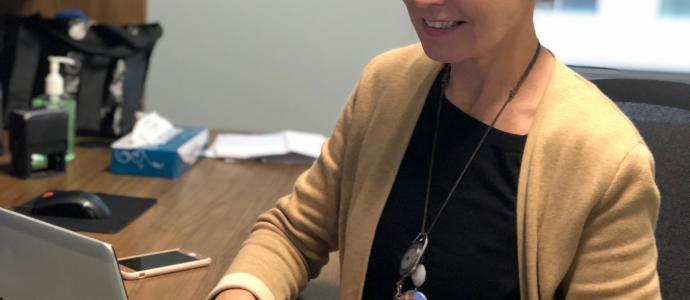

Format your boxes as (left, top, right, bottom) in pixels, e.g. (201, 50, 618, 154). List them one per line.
(558, 144, 661, 300)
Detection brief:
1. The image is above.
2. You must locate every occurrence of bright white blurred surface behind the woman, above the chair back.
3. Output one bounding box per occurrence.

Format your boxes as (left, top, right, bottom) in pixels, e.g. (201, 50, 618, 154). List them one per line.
(535, 0, 690, 74)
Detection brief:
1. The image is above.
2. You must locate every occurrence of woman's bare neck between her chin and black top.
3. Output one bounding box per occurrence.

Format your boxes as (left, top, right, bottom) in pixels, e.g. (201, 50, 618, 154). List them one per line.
(446, 22, 538, 112)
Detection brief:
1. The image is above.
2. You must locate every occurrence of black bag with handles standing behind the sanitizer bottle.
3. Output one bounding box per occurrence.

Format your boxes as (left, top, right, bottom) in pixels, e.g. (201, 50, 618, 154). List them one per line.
(0, 15, 163, 137)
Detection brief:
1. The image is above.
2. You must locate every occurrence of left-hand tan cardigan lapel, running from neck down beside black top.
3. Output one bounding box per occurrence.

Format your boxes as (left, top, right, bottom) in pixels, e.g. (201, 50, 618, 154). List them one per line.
(341, 57, 442, 299)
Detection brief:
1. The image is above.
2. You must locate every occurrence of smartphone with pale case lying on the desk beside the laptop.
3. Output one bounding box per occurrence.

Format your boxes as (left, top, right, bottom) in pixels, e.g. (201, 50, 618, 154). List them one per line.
(117, 248, 211, 280)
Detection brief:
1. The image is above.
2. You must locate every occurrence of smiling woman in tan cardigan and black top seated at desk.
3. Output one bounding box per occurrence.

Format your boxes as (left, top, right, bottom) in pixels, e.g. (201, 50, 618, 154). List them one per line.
(211, 0, 660, 300)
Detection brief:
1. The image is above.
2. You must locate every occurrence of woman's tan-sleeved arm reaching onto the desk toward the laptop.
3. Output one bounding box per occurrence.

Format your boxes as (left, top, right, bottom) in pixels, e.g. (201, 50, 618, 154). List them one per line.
(209, 84, 357, 300)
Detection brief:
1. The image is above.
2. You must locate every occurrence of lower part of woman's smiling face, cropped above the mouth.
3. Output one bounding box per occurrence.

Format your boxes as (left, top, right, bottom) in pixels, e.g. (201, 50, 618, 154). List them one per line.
(404, 0, 534, 63)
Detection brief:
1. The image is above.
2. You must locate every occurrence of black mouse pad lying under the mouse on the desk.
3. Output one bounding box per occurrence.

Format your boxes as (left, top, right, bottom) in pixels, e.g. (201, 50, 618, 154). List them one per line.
(14, 193, 156, 233)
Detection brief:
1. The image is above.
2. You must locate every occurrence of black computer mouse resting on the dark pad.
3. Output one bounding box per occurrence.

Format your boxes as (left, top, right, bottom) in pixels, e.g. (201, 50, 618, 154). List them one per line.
(31, 191, 111, 219)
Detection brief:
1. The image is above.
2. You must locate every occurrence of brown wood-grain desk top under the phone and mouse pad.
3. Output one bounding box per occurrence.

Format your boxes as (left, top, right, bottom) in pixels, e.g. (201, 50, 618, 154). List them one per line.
(0, 147, 337, 300)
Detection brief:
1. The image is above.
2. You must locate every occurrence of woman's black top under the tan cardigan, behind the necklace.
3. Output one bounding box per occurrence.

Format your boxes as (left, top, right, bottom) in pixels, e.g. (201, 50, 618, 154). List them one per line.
(363, 76, 527, 300)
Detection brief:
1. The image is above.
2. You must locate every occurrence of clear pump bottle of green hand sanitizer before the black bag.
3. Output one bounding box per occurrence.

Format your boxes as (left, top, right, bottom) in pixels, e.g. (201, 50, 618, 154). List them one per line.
(31, 56, 77, 161)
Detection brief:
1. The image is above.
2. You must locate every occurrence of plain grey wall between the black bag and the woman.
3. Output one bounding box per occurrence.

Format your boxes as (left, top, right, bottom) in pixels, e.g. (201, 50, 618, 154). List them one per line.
(146, 0, 417, 134)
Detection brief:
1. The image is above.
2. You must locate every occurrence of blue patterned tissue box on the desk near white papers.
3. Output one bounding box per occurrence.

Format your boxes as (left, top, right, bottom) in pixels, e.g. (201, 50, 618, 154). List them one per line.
(110, 127, 208, 179)
